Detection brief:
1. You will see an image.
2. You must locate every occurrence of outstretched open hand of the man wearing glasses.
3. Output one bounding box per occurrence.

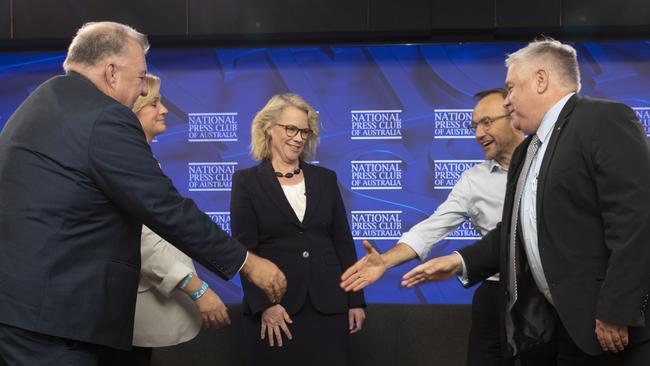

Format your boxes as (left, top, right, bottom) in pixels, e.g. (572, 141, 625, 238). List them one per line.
(341, 240, 388, 292)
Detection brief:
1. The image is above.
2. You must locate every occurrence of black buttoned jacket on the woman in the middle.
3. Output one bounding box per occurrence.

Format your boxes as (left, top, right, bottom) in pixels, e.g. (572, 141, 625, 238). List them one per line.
(230, 161, 365, 314)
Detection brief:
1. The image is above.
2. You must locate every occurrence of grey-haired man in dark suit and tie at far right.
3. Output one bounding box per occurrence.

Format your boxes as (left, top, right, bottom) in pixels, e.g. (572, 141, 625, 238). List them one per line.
(403, 39, 650, 365)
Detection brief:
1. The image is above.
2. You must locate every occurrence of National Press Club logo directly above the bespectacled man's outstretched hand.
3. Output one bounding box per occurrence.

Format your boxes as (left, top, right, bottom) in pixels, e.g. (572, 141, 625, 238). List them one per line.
(350, 211, 402, 240)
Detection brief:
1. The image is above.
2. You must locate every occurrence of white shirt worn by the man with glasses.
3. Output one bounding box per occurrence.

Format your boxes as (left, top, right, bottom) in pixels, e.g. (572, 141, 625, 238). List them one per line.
(399, 160, 508, 281)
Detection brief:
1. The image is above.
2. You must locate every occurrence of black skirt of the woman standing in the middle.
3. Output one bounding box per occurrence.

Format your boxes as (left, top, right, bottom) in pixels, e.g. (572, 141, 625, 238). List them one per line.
(243, 296, 349, 366)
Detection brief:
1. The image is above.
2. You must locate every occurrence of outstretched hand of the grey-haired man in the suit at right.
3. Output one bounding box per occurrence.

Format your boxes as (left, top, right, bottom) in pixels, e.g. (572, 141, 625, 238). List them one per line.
(402, 253, 463, 287)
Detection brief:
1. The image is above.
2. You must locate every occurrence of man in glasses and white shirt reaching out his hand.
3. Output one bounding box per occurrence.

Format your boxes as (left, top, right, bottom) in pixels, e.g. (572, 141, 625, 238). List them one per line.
(341, 89, 530, 366)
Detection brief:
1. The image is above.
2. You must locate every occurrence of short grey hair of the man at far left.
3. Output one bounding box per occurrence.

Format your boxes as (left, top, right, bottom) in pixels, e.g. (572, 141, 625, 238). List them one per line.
(63, 22, 149, 72)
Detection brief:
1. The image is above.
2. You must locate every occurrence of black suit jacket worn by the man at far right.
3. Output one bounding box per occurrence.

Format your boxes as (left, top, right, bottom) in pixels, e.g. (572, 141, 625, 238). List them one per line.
(460, 96, 650, 355)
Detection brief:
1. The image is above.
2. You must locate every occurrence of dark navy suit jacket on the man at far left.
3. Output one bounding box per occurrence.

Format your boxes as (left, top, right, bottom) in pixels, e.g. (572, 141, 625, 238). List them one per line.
(0, 73, 246, 348)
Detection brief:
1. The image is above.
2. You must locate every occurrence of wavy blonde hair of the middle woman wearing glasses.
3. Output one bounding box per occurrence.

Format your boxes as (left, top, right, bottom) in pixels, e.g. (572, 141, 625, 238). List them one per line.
(251, 93, 320, 160)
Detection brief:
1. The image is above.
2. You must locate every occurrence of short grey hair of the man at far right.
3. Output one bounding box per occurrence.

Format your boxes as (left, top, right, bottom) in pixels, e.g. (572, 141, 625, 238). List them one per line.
(506, 37, 580, 93)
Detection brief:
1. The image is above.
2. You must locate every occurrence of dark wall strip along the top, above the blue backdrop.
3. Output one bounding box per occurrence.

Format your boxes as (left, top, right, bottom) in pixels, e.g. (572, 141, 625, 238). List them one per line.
(0, 0, 650, 42)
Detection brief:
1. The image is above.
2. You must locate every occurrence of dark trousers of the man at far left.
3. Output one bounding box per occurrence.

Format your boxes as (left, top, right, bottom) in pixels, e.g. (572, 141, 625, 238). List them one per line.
(0, 324, 108, 366)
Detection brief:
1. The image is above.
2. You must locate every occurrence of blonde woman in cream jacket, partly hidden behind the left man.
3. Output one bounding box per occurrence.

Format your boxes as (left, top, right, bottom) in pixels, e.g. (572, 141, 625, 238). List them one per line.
(100, 75, 230, 365)
